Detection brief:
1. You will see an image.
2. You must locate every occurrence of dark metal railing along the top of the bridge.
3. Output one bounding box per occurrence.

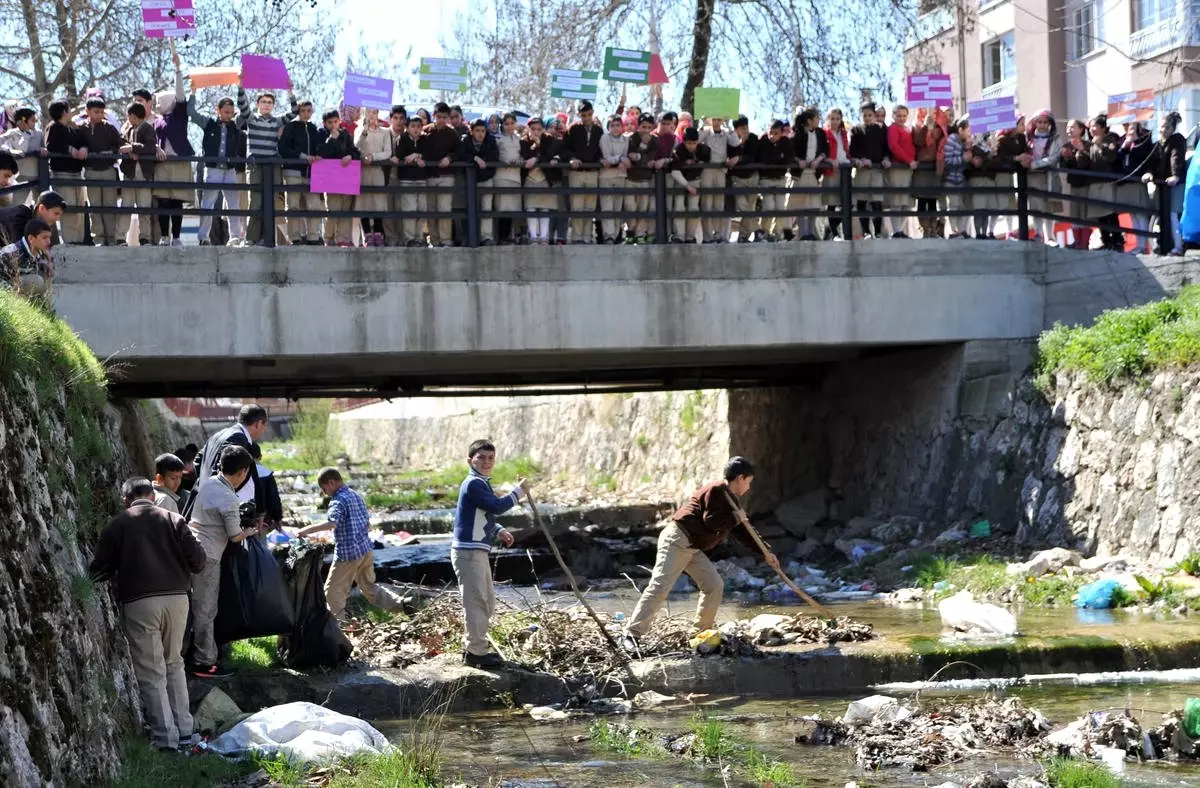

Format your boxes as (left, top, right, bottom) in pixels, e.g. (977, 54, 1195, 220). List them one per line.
(7, 155, 1183, 252)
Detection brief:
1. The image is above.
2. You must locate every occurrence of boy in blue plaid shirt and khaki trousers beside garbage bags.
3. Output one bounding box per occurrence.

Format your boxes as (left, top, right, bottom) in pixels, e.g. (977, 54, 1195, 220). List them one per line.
(298, 468, 397, 631)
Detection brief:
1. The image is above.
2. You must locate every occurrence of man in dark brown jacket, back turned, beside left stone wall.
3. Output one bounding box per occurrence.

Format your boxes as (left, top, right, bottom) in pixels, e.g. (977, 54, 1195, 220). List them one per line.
(89, 479, 204, 750)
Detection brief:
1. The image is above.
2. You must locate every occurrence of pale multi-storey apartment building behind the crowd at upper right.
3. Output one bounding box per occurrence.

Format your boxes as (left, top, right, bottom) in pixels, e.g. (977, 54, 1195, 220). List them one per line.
(905, 0, 1200, 128)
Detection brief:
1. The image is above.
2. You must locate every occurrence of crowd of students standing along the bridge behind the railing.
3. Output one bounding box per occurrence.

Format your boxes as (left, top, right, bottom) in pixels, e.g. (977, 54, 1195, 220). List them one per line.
(0, 63, 1186, 275)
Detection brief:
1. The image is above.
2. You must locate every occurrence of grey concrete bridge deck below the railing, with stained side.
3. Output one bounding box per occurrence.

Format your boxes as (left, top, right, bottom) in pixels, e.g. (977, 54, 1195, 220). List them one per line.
(54, 240, 1190, 396)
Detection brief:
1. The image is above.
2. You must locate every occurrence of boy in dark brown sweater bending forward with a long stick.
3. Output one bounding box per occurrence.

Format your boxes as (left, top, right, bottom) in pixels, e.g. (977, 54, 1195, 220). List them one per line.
(622, 457, 779, 655)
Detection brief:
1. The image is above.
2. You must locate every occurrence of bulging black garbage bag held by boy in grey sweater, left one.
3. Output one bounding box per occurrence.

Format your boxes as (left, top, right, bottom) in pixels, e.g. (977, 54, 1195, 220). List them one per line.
(212, 536, 295, 643)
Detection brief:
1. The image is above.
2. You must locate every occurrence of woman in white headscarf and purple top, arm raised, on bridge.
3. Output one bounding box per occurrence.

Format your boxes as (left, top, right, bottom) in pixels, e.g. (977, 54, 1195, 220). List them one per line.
(154, 40, 196, 246)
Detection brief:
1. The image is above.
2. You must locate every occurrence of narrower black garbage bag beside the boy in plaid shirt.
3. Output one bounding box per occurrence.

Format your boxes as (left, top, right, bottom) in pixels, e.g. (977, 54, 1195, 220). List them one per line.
(278, 541, 354, 670)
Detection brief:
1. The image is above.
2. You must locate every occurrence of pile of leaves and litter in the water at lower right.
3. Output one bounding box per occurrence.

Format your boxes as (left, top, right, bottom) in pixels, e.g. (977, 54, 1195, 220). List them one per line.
(796, 696, 1050, 771)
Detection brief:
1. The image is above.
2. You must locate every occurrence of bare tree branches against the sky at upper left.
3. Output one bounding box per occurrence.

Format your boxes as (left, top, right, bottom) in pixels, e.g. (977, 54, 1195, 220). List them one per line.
(0, 0, 337, 108)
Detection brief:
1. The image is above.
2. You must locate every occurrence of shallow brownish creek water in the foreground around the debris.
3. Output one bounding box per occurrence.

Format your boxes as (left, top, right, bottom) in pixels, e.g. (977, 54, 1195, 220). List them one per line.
(376, 587, 1200, 788)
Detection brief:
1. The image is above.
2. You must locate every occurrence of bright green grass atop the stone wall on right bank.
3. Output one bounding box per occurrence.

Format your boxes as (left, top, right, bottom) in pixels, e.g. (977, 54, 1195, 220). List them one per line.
(1037, 284, 1200, 390)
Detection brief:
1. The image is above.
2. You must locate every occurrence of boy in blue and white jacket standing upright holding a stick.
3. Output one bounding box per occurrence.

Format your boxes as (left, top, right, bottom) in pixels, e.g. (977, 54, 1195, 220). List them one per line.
(450, 440, 529, 668)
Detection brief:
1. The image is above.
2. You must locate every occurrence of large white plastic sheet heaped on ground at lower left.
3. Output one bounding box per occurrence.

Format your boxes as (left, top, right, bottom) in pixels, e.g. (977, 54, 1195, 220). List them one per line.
(210, 702, 391, 763)
